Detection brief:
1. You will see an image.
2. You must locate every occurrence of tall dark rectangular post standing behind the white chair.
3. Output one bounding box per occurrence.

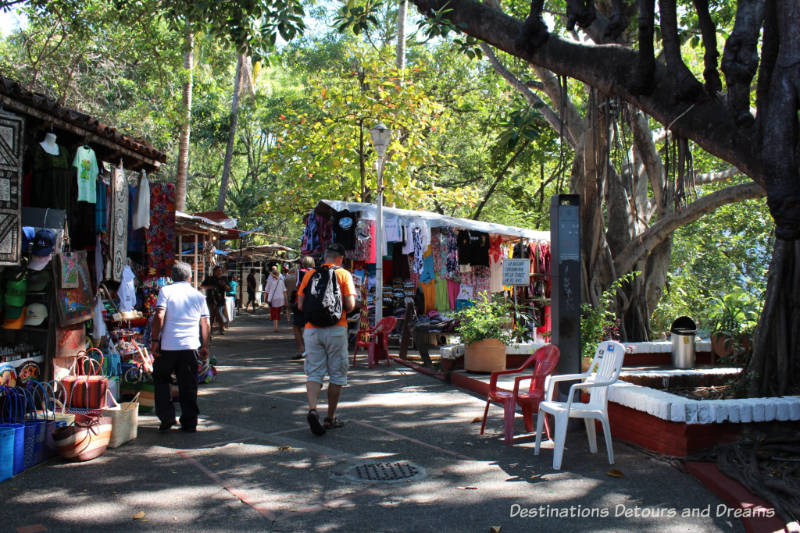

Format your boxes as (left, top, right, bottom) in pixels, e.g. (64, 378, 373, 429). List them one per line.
(550, 194, 581, 398)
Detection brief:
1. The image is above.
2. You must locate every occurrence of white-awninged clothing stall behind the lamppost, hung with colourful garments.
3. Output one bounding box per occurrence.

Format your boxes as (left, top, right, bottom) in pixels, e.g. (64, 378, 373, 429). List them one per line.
(301, 200, 550, 350)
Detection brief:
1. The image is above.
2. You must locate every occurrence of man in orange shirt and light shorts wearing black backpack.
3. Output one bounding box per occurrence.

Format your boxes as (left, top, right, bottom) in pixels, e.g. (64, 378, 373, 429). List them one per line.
(297, 243, 356, 435)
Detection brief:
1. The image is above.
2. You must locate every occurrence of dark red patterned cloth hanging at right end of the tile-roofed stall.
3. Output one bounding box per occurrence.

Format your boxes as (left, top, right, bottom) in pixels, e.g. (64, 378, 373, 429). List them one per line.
(146, 183, 175, 278)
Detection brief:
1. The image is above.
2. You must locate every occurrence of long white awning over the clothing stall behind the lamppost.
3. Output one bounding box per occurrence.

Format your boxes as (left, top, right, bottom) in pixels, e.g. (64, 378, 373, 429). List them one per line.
(316, 200, 550, 242)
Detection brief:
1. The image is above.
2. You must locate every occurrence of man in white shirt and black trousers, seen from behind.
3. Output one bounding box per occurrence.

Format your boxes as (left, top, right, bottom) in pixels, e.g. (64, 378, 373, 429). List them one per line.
(150, 263, 211, 433)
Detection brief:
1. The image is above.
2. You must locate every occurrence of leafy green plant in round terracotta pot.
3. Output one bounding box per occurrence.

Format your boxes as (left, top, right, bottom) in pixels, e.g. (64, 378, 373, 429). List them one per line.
(456, 294, 511, 372)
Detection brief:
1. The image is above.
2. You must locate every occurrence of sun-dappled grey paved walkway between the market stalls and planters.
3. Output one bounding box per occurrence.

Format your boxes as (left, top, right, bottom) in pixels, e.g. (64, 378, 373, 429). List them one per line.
(0, 314, 743, 533)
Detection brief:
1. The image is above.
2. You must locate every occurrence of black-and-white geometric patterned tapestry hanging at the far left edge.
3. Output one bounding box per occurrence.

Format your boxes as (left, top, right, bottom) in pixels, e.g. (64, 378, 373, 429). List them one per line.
(0, 111, 24, 265)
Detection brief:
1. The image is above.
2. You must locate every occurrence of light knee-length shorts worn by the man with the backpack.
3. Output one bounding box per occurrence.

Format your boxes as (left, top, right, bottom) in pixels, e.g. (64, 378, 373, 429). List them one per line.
(303, 326, 347, 386)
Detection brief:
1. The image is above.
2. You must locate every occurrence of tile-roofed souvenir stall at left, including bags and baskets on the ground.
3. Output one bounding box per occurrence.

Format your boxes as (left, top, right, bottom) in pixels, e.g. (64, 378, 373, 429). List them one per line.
(0, 76, 175, 470)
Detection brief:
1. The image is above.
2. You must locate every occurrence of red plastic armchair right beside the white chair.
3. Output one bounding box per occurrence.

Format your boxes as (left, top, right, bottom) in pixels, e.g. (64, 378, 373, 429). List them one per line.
(481, 344, 561, 446)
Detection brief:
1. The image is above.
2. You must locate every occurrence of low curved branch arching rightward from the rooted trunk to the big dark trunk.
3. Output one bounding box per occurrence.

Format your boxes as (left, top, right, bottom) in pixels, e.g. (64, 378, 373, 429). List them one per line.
(614, 183, 766, 272)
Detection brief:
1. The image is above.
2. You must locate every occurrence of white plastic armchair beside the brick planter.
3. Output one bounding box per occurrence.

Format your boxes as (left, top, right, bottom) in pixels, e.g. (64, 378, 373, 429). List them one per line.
(534, 341, 625, 470)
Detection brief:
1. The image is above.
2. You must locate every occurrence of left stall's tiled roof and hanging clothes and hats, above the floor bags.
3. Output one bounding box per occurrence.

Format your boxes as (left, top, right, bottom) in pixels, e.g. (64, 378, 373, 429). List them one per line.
(0, 77, 169, 386)
